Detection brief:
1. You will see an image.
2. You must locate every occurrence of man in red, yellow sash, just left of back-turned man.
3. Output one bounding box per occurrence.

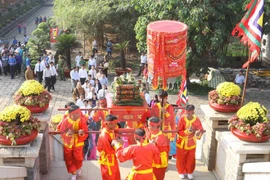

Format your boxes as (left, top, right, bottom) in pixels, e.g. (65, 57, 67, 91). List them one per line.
(97, 114, 121, 180)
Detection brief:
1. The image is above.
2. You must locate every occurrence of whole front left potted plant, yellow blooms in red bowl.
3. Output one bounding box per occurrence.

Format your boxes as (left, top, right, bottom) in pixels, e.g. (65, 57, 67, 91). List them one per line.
(0, 105, 40, 145)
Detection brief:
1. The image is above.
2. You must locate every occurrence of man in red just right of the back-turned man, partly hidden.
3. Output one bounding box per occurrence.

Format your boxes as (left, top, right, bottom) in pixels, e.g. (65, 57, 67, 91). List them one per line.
(148, 117, 170, 180)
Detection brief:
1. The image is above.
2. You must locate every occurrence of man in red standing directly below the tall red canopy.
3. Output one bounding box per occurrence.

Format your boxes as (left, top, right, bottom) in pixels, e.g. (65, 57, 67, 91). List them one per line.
(151, 91, 176, 141)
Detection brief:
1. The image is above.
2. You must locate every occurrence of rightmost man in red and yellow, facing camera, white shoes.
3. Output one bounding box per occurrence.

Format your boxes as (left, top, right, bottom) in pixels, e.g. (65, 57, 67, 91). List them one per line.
(176, 104, 204, 179)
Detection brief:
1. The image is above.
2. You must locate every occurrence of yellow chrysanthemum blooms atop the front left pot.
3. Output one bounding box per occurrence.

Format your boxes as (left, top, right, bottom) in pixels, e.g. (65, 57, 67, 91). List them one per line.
(0, 104, 31, 122)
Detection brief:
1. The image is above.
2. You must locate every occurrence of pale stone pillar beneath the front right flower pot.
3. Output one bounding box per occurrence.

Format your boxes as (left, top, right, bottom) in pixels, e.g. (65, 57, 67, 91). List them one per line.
(213, 132, 270, 180)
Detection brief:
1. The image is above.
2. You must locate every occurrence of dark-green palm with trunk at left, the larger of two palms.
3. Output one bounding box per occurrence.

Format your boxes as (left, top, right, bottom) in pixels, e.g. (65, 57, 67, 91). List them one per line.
(55, 33, 78, 69)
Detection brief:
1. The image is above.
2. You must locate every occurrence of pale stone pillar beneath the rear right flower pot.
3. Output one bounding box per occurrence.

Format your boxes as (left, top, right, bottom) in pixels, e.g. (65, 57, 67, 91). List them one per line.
(201, 105, 234, 171)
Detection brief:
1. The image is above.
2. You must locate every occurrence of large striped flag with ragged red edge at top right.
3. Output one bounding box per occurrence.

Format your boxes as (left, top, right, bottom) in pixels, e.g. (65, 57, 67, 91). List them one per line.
(232, 0, 264, 68)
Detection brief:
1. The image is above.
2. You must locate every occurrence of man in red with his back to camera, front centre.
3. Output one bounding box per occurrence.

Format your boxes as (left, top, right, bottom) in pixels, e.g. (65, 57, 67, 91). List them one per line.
(112, 129, 160, 180)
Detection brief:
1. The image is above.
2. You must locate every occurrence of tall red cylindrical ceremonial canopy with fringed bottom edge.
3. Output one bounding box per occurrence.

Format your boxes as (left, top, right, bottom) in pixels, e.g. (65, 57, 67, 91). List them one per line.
(147, 20, 188, 89)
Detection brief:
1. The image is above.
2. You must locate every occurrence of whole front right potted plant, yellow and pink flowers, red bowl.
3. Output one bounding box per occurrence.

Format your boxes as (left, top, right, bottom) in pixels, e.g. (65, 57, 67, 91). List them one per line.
(229, 102, 270, 142)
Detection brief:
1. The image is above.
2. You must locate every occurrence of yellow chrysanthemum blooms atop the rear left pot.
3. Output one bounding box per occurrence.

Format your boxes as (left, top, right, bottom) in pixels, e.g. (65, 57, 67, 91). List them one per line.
(16, 80, 44, 96)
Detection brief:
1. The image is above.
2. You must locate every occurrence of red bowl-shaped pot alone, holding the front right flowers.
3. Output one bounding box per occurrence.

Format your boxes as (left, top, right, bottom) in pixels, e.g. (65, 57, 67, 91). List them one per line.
(231, 128, 270, 143)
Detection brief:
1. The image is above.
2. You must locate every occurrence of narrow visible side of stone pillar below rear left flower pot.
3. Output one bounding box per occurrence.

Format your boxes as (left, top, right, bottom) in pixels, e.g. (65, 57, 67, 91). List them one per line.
(39, 122, 50, 174)
